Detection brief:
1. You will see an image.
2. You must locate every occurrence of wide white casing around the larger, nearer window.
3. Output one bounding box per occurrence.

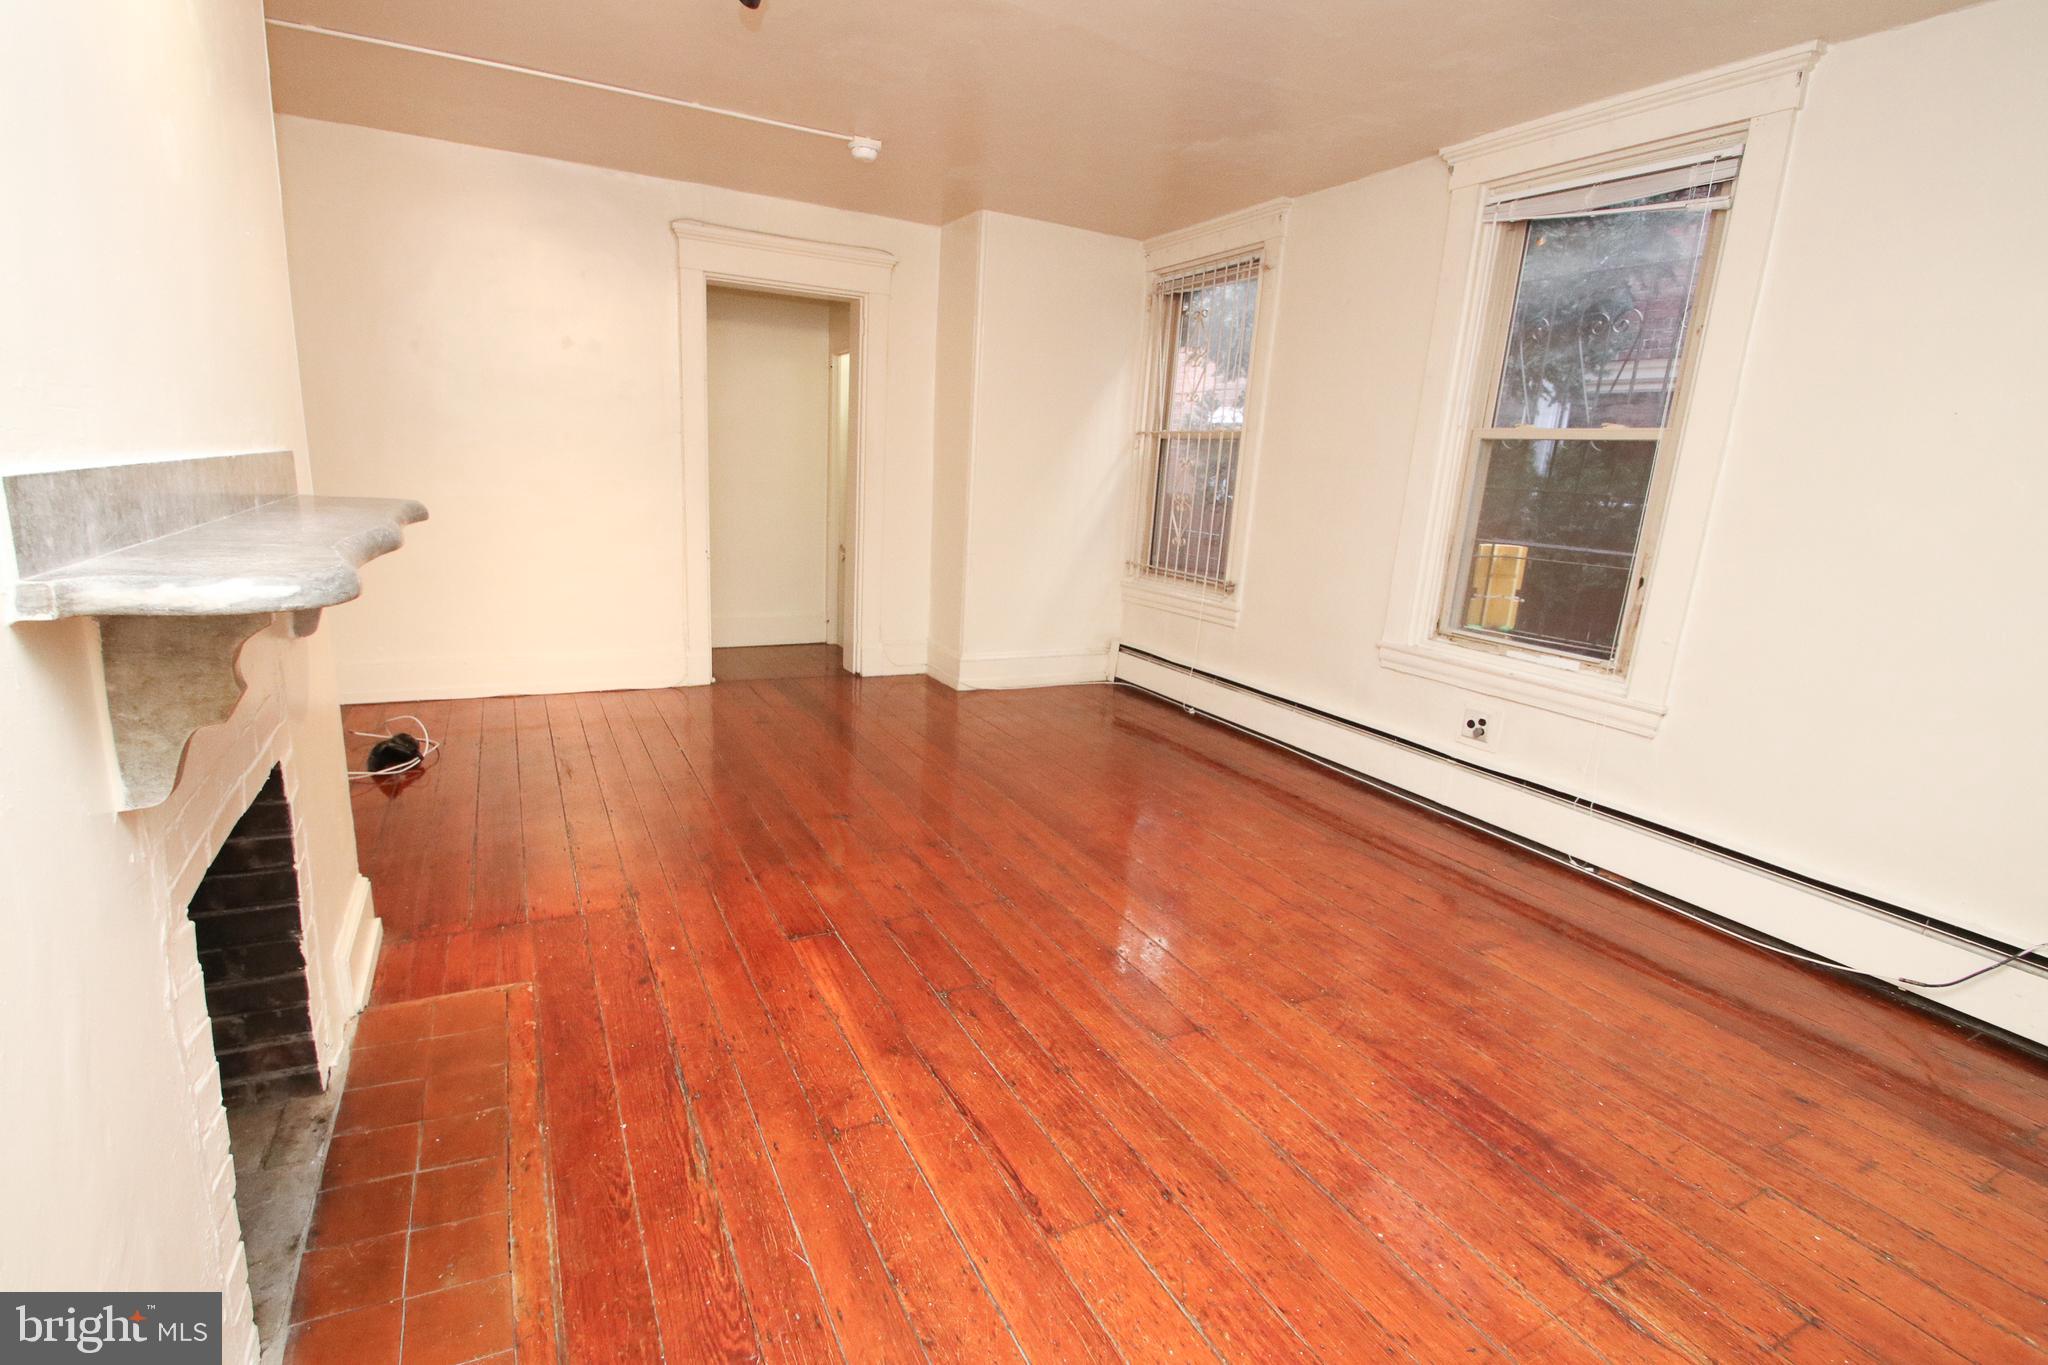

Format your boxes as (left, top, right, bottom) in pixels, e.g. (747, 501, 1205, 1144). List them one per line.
(1378, 43, 1821, 735)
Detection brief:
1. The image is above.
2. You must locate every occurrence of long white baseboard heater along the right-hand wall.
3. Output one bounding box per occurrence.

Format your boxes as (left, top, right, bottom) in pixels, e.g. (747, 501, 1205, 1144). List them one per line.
(1116, 653, 2048, 1046)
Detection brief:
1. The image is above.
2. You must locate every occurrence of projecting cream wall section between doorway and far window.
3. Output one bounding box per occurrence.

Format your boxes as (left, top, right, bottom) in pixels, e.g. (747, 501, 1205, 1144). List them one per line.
(932, 213, 1145, 688)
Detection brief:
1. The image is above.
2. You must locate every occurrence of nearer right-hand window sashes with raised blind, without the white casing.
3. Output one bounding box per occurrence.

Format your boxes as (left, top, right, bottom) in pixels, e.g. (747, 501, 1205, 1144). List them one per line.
(1442, 147, 1741, 665)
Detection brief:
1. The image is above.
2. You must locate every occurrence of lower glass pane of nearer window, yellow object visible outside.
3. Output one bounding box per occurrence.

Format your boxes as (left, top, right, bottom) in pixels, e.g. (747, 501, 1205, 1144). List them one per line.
(1458, 440, 1657, 659)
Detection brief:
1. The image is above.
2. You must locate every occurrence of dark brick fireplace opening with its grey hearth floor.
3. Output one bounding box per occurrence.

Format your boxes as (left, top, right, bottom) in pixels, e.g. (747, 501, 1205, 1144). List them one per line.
(186, 767, 338, 1359)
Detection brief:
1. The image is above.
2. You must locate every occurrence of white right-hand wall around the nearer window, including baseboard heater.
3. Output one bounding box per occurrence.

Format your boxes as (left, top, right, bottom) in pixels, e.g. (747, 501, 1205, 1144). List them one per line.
(1124, 0, 2048, 1038)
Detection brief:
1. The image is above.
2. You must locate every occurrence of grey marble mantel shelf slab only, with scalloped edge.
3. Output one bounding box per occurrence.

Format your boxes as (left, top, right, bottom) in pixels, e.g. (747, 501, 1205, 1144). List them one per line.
(12, 495, 426, 634)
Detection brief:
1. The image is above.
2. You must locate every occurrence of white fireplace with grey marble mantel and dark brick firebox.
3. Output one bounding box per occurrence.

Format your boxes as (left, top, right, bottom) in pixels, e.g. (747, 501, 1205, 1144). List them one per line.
(0, 448, 426, 1361)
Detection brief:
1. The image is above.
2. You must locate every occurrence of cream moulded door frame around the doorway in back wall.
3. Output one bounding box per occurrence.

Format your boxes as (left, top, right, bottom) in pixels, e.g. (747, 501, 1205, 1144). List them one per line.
(670, 219, 895, 688)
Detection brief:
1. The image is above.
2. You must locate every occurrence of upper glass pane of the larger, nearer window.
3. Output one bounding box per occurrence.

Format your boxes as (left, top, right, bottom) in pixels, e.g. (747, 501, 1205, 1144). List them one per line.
(1493, 209, 1708, 428)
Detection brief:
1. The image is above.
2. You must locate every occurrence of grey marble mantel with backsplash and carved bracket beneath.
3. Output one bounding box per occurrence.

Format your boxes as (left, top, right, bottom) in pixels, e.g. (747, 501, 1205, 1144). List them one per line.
(0, 450, 426, 810)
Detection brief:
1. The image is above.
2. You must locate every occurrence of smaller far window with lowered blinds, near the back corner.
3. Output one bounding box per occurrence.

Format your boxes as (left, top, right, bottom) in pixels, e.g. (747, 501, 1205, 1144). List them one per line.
(1133, 256, 1260, 591)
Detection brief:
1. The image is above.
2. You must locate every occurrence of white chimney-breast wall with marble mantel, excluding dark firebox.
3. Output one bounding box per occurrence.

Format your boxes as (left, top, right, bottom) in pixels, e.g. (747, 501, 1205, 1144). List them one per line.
(0, 4, 418, 1365)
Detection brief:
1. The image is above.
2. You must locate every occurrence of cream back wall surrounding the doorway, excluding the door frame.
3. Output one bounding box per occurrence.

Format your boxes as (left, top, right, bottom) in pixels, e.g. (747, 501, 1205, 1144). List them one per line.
(279, 119, 938, 700)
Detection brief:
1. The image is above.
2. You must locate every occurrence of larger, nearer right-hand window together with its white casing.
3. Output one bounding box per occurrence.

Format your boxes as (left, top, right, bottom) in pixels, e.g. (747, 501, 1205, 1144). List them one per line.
(1378, 43, 1821, 735)
